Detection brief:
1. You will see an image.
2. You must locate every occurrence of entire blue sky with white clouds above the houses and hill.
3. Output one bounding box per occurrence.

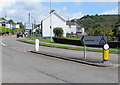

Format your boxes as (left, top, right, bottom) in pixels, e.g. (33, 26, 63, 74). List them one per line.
(0, 0, 119, 23)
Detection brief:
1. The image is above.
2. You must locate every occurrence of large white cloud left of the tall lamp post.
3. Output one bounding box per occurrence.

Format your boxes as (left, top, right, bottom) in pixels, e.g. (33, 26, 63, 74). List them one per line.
(0, 2, 49, 23)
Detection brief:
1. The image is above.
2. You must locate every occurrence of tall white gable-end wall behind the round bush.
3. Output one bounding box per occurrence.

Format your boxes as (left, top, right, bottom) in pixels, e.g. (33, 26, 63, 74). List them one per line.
(43, 14, 66, 37)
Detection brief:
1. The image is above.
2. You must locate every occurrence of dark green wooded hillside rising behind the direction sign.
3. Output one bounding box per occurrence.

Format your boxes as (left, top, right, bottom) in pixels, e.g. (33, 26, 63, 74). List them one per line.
(72, 15, 118, 40)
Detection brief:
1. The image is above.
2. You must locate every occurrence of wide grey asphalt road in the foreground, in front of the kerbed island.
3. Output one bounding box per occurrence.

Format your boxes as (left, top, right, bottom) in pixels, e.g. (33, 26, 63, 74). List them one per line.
(0, 37, 118, 83)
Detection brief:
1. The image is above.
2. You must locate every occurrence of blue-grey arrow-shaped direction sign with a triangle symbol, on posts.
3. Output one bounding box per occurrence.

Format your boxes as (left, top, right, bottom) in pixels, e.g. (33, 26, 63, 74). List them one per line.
(81, 36, 107, 45)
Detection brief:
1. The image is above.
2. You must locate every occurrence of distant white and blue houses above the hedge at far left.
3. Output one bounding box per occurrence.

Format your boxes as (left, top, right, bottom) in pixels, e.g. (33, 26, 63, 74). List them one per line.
(0, 20, 20, 29)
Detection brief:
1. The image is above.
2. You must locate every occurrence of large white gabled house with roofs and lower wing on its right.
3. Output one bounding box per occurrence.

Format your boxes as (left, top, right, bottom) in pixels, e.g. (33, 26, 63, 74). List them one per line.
(41, 12, 84, 37)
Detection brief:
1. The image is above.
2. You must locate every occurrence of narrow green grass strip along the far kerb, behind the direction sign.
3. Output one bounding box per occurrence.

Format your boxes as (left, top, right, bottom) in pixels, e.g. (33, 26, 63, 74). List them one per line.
(17, 40, 120, 53)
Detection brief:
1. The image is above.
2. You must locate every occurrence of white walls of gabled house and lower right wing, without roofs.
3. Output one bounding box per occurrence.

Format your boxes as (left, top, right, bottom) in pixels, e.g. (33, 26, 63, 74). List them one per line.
(42, 14, 84, 37)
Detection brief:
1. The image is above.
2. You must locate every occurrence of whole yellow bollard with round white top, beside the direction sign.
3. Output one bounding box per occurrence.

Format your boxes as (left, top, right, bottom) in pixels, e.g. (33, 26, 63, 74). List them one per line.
(103, 44, 109, 63)
